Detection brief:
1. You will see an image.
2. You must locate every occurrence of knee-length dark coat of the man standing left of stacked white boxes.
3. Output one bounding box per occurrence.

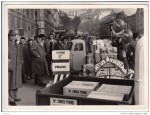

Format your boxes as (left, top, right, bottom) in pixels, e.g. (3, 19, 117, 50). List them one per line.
(30, 41, 49, 75)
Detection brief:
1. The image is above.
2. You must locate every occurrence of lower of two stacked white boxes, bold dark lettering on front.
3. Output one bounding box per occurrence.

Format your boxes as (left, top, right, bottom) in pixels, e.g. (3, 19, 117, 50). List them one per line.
(52, 62, 70, 72)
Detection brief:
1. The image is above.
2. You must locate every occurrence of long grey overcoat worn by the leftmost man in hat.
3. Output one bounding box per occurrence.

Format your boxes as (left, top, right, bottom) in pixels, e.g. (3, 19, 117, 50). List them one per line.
(8, 41, 23, 89)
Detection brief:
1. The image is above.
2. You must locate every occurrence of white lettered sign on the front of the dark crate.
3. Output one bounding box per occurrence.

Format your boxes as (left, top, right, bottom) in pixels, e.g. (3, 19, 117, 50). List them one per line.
(50, 97, 77, 105)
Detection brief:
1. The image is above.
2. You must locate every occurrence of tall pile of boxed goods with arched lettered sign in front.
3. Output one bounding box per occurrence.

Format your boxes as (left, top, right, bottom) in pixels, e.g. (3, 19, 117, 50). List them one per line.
(83, 39, 134, 79)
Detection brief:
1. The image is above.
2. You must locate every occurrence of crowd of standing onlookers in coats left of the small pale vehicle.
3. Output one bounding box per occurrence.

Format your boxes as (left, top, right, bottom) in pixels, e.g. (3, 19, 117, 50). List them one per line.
(8, 30, 72, 105)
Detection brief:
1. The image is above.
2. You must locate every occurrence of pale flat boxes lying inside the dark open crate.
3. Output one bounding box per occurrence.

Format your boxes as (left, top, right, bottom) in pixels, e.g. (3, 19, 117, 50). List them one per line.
(63, 81, 132, 101)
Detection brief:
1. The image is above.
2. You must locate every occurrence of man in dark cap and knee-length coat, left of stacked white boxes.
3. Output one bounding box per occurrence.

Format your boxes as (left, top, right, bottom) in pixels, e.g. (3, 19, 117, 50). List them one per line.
(31, 34, 49, 85)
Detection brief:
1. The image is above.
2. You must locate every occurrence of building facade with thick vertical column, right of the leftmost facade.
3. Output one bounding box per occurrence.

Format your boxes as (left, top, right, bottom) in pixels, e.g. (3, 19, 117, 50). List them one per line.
(35, 9, 60, 36)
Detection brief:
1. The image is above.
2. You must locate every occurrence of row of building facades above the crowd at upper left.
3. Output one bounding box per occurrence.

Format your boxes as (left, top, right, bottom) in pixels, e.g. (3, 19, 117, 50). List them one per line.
(8, 9, 60, 39)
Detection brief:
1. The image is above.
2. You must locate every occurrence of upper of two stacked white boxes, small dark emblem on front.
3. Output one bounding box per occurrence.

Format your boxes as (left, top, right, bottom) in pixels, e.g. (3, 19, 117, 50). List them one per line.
(52, 50, 70, 60)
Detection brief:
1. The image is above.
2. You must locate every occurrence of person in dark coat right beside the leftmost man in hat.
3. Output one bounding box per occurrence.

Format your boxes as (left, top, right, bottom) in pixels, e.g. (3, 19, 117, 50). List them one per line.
(19, 37, 30, 83)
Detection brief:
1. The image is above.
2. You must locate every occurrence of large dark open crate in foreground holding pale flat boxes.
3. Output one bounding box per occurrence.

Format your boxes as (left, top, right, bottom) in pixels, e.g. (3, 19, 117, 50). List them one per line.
(36, 76, 134, 105)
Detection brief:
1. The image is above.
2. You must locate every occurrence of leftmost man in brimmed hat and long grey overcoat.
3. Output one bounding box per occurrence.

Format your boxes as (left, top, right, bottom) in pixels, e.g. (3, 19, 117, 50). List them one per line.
(8, 30, 23, 105)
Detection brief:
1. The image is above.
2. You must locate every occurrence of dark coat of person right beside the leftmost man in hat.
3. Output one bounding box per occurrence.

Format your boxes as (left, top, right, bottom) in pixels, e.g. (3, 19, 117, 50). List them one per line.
(20, 43, 30, 74)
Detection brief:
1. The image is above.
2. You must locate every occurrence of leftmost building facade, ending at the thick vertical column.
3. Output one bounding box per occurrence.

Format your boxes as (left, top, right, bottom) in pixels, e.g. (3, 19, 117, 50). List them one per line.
(8, 9, 35, 38)
